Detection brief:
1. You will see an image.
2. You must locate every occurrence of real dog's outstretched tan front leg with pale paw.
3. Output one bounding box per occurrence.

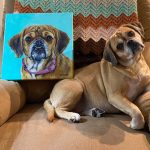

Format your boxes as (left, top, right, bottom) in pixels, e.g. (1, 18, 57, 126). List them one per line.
(108, 94, 145, 129)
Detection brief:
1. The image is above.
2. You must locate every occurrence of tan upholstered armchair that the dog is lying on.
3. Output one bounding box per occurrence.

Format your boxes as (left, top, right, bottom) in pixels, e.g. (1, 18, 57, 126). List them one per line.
(0, 0, 150, 150)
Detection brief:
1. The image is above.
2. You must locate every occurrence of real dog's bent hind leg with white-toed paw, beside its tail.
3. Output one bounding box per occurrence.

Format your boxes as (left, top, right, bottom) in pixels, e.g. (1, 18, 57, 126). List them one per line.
(44, 79, 83, 122)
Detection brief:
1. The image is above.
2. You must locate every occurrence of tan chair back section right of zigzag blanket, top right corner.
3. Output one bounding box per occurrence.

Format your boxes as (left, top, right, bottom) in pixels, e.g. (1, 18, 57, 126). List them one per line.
(137, 0, 150, 41)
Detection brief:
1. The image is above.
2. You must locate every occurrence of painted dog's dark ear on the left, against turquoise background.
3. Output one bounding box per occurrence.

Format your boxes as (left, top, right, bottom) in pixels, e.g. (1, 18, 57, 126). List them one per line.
(9, 34, 23, 57)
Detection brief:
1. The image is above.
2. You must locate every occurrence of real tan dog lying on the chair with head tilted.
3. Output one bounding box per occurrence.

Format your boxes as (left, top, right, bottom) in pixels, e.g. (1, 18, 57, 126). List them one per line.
(44, 23, 150, 129)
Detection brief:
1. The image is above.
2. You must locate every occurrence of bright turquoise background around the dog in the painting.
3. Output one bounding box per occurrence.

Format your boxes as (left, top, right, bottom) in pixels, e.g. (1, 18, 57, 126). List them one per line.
(2, 13, 73, 80)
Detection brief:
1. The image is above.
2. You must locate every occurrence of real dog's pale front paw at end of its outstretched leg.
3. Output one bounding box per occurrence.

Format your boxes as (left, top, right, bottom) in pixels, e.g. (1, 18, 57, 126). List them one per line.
(130, 114, 145, 130)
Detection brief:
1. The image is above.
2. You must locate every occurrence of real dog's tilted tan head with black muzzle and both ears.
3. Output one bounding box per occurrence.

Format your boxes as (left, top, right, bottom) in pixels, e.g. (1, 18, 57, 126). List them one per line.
(103, 23, 144, 67)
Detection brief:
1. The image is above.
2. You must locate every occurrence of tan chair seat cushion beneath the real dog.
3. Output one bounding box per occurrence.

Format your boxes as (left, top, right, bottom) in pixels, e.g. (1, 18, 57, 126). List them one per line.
(0, 104, 150, 150)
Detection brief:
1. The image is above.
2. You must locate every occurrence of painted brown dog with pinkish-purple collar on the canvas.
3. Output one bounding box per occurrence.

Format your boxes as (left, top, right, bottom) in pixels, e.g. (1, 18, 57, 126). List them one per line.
(9, 25, 73, 79)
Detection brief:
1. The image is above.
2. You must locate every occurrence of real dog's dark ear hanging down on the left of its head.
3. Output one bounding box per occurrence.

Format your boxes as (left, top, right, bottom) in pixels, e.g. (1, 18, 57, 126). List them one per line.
(103, 42, 118, 66)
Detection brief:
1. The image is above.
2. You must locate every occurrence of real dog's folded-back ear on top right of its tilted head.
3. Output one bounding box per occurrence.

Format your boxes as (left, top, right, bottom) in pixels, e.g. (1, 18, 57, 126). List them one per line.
(125, 22, 144, 39)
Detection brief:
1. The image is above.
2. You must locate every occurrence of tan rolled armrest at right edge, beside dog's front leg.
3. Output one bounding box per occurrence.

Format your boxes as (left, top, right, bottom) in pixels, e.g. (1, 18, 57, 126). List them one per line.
(135, 91, 150, 131)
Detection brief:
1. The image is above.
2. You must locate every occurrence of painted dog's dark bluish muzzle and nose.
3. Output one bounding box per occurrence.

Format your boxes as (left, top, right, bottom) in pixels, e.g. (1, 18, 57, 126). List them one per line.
(31, 39, 46, 61)
